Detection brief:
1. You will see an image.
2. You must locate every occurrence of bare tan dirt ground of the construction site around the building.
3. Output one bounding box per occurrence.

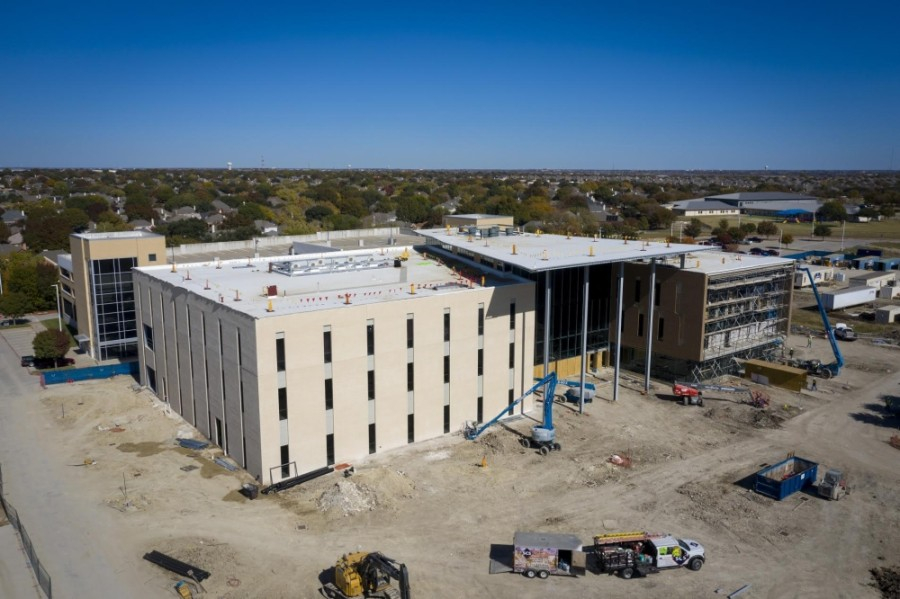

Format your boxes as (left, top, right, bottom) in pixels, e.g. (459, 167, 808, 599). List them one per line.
(12, 336, 900, 599)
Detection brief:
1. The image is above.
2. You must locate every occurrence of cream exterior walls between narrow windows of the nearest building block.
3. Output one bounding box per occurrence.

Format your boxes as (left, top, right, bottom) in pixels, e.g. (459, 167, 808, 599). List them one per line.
(135, 273, 534, 483)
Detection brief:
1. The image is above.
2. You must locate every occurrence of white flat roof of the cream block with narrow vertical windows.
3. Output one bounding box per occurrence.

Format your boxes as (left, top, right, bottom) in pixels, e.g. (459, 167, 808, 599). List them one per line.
(134, 246, 525, 318)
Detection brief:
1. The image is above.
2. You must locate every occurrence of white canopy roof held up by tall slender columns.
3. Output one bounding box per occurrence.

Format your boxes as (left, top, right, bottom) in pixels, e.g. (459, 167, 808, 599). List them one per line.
(418, 227, 714, 272)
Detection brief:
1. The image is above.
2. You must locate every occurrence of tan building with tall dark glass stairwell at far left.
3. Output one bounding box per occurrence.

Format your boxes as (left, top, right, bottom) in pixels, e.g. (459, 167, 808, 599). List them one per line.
(58, 231, 166, 361)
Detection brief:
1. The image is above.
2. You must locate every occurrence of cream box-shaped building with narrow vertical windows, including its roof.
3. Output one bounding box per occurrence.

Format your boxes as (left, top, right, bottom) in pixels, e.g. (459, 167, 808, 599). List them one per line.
(134, 248, 535, 484)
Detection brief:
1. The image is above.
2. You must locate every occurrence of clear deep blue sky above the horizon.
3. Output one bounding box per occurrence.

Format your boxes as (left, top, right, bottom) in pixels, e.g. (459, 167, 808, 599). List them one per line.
(0, 0, 900, 169)
